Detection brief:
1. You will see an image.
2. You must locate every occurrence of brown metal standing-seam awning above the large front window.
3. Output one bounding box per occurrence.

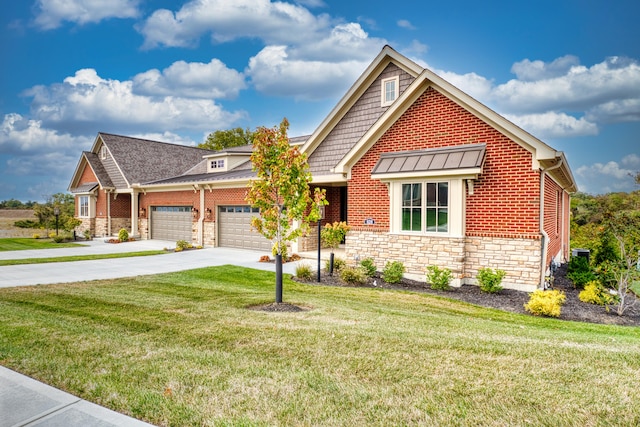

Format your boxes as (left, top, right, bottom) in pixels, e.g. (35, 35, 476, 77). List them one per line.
(371, 144, 486, 179)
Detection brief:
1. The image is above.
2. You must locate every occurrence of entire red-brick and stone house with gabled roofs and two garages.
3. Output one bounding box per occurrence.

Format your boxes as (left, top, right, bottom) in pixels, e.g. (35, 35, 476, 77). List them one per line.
(70, 46, 577, 291)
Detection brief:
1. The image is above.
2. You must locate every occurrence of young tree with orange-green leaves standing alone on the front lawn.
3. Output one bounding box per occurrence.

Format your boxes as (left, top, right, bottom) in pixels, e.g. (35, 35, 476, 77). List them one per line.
(246, 118, 327, 303)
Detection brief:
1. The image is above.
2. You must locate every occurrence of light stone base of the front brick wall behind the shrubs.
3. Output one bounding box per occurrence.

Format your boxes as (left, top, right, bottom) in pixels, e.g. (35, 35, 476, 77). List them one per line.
(345, 230, 542, 292)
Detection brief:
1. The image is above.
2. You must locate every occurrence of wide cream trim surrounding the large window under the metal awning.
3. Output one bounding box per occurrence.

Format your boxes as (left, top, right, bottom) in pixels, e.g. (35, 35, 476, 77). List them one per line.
(389, 177, 466, 237)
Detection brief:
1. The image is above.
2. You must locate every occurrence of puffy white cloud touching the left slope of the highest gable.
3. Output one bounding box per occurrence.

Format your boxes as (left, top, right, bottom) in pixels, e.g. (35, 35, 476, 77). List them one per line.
(247, 46, 368, 99)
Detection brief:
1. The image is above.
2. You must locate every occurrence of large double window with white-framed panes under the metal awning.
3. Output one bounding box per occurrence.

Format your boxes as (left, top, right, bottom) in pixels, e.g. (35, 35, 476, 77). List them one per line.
(401, 182, 449, 233)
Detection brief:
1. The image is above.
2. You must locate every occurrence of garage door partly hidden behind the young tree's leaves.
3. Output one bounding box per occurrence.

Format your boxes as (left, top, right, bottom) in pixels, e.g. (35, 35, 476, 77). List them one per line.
(218, 206, 271, 252)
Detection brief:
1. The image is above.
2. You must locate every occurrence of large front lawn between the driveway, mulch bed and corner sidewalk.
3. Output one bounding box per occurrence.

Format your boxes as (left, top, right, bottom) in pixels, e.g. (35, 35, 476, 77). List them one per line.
(0, 266, 640, 426)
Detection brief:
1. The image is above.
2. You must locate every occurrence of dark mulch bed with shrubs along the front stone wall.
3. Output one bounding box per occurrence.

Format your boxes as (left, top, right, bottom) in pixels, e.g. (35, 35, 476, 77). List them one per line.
(294, 265, 640, 326)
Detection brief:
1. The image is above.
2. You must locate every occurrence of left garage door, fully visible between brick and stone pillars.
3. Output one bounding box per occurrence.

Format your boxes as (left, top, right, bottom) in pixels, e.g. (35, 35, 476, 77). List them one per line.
(151, 206, 193, 242)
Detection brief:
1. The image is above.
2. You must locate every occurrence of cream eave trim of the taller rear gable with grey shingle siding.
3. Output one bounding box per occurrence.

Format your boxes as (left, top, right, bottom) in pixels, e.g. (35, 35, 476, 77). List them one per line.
(300, 46, 423, 155)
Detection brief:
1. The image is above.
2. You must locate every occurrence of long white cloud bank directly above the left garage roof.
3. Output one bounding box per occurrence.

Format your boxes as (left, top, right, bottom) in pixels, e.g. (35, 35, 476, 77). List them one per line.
(25, 68, 245, 134)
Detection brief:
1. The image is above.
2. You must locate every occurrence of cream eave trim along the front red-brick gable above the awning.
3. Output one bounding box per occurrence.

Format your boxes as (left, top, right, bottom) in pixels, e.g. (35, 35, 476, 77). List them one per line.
(334, 69, 575, 192)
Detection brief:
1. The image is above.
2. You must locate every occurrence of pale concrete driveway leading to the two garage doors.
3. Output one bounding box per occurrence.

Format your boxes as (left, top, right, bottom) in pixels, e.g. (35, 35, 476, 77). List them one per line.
(0, 239, 296, 288)
